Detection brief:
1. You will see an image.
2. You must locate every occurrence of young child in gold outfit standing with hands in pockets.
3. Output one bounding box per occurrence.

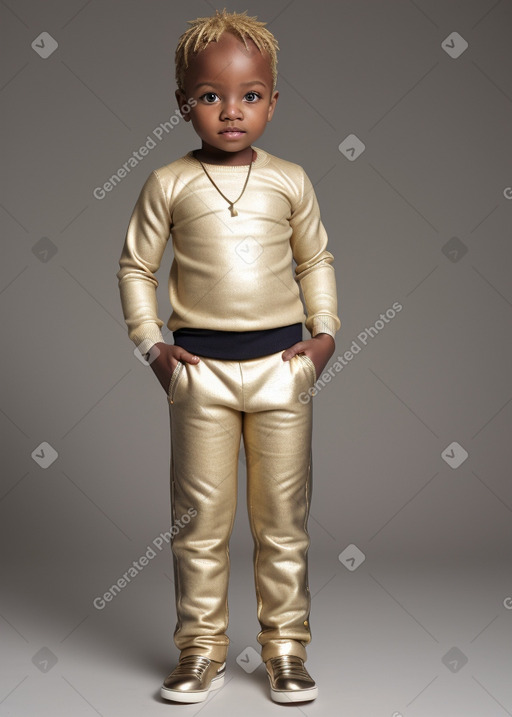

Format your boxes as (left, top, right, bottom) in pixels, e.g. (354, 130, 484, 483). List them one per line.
(117, 10, 340, 703)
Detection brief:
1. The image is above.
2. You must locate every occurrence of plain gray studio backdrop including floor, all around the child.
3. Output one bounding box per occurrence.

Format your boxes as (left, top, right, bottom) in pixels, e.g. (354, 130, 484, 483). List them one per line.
(0, 0, 512, 717)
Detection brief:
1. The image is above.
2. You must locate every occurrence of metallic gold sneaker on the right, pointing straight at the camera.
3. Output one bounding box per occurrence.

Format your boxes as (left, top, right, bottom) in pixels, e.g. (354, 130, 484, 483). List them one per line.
(265, 655, 318, 703)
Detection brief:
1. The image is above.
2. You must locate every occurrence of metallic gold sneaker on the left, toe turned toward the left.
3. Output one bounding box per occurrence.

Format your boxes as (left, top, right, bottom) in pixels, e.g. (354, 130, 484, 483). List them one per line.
(160, 655, 226, 702)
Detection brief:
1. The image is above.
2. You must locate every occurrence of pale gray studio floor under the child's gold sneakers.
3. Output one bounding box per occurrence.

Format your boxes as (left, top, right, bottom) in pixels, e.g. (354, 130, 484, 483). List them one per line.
(0, 548, 512, 717)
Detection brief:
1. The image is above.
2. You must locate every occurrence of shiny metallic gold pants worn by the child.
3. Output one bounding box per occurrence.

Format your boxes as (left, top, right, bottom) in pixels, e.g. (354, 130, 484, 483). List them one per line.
(167, 351, 316, 662)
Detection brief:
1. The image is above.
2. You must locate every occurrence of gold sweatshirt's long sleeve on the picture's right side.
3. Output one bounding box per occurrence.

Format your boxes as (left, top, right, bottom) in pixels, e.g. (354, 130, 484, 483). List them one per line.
(290, 171, 341, 337)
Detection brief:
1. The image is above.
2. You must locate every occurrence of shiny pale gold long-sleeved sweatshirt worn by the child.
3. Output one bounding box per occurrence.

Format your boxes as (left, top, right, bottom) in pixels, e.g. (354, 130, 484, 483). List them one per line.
(116, 147, 341, 353)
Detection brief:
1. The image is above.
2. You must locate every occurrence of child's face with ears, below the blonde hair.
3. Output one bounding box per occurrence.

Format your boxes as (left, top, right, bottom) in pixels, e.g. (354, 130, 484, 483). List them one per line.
(176, 32, 279, 160)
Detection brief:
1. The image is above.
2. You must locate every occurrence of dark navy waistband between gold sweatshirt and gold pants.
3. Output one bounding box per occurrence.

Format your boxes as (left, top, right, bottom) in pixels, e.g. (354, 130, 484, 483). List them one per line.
(173, 322, 302, 360)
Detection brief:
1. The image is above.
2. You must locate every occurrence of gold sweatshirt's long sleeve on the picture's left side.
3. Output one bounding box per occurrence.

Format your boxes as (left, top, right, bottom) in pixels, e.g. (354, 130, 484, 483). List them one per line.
(116, 171, 171, 353)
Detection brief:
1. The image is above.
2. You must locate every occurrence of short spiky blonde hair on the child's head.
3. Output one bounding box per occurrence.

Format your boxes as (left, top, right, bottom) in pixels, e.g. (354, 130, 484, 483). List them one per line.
(175, 8, 279, 91)
